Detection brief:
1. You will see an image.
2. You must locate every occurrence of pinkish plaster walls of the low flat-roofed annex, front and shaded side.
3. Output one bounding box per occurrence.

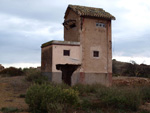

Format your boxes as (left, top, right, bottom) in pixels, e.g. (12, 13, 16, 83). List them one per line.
(41, 45, 81, 83)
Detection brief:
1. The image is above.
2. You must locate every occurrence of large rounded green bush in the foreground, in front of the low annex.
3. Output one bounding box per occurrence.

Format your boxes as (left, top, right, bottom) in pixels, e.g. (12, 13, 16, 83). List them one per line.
(25, 84, 79, 113)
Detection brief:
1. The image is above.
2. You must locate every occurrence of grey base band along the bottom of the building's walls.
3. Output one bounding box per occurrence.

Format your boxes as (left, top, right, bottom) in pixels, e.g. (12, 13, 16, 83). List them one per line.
(42, 72, 112, 86)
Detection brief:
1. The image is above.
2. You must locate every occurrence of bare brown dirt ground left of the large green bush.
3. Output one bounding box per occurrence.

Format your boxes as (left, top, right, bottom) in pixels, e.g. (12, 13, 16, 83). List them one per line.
(0, 76, 29, 113)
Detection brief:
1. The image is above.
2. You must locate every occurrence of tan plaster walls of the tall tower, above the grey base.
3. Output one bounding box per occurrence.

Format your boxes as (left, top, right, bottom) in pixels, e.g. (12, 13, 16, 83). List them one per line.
(64, 10, 112, 73)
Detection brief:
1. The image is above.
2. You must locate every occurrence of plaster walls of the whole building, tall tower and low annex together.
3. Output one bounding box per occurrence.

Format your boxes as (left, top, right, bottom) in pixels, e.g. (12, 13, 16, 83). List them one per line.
(42, 7, 112, 86)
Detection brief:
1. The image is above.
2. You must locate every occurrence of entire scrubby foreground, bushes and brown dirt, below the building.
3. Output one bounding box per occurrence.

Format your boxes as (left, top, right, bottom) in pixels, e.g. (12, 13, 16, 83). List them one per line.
(0, 64, 150, 113)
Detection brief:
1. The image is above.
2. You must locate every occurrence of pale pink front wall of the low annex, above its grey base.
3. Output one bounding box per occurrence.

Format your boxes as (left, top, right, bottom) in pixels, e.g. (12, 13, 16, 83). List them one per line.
(52, 45, 81, 72)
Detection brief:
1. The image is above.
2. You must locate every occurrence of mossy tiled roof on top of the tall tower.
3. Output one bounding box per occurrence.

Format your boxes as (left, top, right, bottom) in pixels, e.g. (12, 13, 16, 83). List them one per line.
(68, 5, 115, 20)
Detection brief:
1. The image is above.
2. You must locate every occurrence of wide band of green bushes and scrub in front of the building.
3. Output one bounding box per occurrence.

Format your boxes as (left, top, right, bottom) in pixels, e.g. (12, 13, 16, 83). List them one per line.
(26, 83, 150, 113)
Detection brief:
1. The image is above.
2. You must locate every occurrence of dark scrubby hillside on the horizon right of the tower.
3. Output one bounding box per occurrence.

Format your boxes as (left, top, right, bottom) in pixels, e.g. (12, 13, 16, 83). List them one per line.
(112, 59, 150, 78)
